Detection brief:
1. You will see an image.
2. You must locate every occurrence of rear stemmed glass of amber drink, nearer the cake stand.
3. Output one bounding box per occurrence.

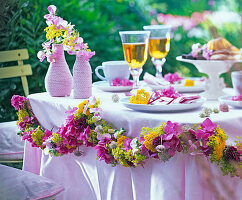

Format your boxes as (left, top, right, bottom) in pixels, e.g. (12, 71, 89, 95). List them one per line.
(143, 25, 171, 78)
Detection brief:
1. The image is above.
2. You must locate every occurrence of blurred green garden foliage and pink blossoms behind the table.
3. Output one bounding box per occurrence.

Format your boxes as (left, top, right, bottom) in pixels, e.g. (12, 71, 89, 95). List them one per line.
(0, 0, 242, 122)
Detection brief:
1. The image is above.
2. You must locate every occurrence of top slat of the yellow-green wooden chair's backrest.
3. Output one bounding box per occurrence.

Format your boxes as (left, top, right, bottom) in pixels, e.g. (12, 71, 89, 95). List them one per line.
(0, 49, 29, 62)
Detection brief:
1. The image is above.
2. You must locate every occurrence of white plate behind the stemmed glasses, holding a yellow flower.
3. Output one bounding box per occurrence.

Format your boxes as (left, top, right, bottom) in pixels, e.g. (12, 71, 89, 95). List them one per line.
(147, 77, 205, 92)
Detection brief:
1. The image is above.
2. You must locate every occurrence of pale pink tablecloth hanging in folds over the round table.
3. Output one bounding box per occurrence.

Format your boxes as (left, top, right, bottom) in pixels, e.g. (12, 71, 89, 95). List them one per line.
(24, 90, 242, 200)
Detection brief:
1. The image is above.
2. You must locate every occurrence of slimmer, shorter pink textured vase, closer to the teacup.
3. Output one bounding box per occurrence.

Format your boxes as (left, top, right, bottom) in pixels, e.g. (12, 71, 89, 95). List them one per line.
(73, 56, 92, 99)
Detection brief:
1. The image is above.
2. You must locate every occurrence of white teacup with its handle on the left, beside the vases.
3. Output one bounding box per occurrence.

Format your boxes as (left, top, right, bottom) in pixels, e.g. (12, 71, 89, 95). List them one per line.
(95, 61, 130, 83)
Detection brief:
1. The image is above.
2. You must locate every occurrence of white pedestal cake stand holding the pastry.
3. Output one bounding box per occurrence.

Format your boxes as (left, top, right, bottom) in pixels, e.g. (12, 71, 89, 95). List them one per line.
(176, 56, 242, 100)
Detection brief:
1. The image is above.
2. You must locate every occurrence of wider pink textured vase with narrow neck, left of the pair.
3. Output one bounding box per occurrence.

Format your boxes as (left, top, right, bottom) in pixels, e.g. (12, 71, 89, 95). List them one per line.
(45, 44, 72, 97)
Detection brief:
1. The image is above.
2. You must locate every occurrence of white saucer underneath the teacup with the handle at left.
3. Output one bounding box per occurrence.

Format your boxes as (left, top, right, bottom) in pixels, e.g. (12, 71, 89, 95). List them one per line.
(92, 81, 133, 92)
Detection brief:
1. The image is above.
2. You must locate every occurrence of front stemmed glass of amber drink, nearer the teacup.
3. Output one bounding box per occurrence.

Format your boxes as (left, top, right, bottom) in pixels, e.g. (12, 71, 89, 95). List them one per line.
(119, 31, 150, 91)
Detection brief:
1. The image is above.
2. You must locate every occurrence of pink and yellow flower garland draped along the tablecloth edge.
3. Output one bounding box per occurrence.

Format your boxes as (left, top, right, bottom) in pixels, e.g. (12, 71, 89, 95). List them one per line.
(11, 95, 242, 178)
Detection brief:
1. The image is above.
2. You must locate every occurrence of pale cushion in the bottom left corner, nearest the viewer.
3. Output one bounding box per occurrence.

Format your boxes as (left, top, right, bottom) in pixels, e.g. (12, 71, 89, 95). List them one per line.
(0, 165, 64, 199)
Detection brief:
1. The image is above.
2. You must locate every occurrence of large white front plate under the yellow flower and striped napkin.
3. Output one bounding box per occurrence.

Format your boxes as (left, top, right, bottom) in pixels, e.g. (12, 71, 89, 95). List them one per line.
(120, 97, 206, 112)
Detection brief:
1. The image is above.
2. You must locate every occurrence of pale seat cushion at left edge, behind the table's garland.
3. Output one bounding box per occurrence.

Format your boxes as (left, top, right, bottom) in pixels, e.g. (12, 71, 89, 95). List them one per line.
(0, 121, 24, 160)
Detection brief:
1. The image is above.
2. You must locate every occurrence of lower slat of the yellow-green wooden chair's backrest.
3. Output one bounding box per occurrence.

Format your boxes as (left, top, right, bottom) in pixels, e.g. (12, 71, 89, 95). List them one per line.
(0, 65, 32, 79)
